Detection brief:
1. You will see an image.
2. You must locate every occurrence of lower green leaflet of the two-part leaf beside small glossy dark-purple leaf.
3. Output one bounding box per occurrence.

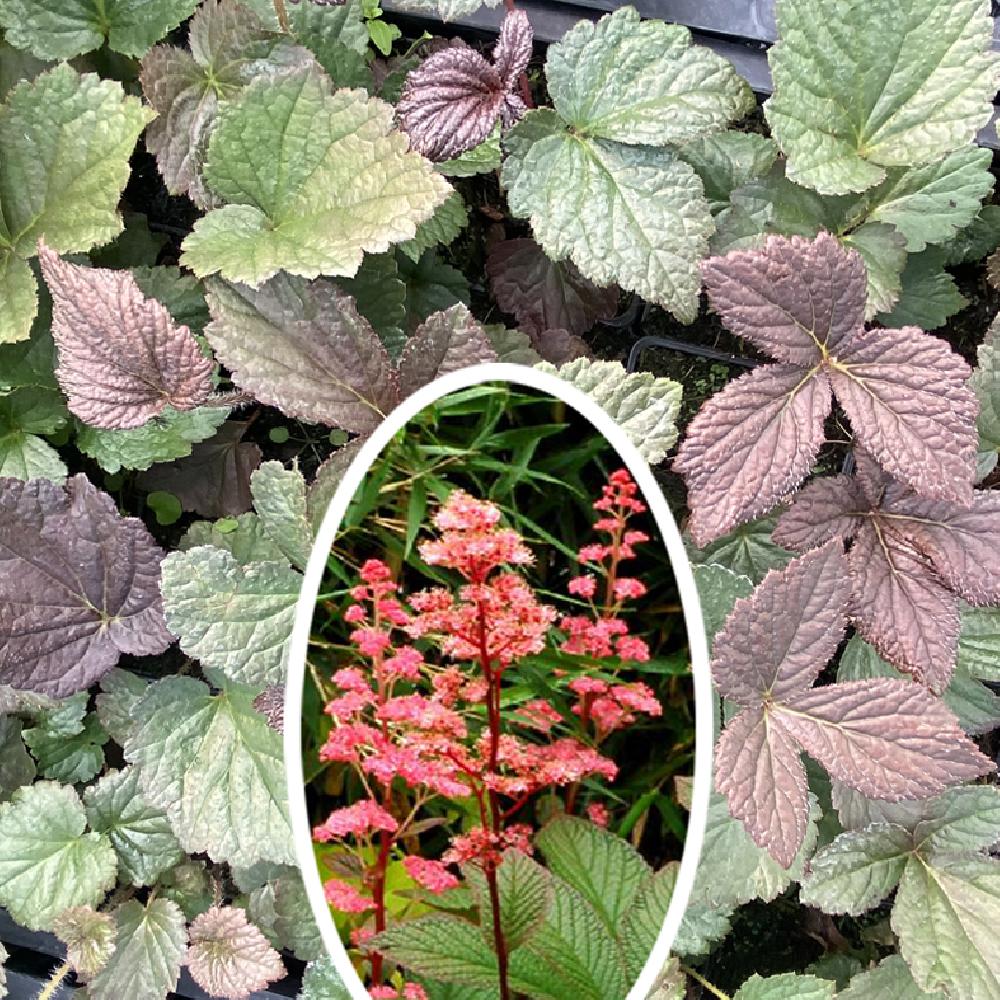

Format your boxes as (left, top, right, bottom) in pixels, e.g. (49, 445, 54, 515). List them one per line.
(501, 110, 714, 322)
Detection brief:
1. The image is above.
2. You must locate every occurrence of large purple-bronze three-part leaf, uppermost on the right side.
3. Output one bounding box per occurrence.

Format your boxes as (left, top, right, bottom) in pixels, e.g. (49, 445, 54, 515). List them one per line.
(674, 233, 976, 545)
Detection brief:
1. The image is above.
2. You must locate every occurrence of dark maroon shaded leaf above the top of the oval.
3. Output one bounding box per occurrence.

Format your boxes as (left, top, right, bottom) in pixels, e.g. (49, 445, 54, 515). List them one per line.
(486, 239, 619, 334)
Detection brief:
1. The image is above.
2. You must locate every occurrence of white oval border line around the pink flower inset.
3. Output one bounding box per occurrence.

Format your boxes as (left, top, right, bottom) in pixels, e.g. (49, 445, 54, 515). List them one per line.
(284, 362, 713, 1000)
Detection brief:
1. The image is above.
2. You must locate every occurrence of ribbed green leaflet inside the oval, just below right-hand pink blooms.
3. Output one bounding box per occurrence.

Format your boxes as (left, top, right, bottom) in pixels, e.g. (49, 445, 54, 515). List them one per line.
(535, 816, 652, 934)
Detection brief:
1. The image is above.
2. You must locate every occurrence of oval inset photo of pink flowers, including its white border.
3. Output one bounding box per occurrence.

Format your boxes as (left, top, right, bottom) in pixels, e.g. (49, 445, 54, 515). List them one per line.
(285, 364, 712, 1000)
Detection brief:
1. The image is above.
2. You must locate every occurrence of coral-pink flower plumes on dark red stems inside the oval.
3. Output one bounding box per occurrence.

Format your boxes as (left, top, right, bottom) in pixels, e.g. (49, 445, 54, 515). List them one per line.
(313, 470, 663, 997)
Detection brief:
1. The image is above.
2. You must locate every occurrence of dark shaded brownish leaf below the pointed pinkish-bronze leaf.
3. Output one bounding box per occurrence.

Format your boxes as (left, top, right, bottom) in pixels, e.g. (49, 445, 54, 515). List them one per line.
(138, 420, 261, 517)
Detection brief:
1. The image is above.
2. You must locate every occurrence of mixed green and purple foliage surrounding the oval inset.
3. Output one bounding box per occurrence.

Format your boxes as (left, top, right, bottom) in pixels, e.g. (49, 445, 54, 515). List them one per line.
(0, 0, 1000, 1000)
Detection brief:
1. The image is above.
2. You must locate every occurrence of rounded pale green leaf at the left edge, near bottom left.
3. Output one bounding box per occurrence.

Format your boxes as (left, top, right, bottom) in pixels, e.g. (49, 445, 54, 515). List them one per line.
(0, 781, 117, 930)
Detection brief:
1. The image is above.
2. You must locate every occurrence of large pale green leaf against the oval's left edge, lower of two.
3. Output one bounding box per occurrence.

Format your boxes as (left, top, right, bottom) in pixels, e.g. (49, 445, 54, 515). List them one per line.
(125, 677, 294, 865)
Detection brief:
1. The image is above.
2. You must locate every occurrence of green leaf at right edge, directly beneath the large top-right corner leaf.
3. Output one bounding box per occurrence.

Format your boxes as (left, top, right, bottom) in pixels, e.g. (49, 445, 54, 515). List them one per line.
(868, 146, 993, 253)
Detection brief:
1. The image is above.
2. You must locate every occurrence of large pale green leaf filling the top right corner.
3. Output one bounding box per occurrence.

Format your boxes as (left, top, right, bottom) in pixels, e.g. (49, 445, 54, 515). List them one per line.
(765, 0, 997, 194)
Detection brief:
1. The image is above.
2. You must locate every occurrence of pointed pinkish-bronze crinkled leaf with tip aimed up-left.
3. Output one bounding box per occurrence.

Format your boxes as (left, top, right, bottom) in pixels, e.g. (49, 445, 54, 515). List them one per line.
(39, 242, 213, 430)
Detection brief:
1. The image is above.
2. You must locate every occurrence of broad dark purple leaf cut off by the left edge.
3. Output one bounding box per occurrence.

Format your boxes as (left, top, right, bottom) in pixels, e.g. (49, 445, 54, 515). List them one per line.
(0, 475, 171, 696)
